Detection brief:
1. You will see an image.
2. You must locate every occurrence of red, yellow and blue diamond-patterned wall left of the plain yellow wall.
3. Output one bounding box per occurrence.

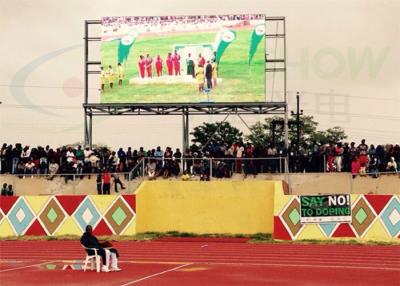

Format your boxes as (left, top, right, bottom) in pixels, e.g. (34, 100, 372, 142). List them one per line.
(0, 195, 136, 237)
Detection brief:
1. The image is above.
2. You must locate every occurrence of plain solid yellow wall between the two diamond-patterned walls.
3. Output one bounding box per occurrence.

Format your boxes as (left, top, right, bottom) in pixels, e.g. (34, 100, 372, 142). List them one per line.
(136, 180, 282, 234)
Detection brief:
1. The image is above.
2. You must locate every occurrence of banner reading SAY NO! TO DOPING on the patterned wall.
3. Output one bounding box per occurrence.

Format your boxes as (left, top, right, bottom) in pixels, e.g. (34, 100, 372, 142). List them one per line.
(300, 195, 351, 223)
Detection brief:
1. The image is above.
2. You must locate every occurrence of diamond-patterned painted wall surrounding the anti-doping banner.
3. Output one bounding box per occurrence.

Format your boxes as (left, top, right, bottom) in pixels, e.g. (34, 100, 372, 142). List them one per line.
(273, 191, 400, 241)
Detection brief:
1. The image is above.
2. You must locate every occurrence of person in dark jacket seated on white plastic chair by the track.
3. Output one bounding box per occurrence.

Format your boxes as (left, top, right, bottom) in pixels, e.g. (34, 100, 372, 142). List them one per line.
(81, 225, 121, 272)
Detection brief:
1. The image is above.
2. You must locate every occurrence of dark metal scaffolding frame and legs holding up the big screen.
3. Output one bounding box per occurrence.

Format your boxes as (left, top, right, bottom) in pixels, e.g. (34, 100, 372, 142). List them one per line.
(83, 17, 288, 150)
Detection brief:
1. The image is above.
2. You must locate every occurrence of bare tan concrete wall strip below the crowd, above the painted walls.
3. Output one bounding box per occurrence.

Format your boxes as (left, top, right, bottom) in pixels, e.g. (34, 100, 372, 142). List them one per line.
(0, 173, 400, 195)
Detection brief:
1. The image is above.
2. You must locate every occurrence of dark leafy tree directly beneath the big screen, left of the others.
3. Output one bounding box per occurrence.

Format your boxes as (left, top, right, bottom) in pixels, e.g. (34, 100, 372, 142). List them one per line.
(190, 122, 243, 147)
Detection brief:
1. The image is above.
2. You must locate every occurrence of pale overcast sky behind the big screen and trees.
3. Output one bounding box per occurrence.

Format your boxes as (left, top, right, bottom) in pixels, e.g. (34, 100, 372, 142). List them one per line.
(0, 0, 400, 148)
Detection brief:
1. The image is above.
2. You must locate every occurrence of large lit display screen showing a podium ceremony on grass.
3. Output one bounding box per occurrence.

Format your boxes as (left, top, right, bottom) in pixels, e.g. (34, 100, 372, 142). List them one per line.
(99, 15, 266, 103)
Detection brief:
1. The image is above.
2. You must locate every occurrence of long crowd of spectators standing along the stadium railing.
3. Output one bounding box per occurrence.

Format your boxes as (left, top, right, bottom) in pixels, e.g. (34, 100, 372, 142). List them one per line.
(0, 140, 400, 181)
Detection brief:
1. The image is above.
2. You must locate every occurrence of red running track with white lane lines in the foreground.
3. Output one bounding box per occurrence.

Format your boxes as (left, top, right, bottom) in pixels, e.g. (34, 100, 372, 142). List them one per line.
(0, 241, 400, 286)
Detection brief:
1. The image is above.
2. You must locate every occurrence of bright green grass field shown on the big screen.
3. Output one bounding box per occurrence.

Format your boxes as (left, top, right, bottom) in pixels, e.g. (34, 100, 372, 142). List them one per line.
(101, 29, 265, 103)
